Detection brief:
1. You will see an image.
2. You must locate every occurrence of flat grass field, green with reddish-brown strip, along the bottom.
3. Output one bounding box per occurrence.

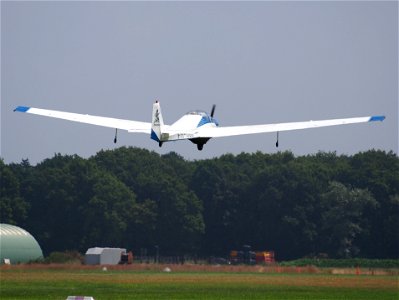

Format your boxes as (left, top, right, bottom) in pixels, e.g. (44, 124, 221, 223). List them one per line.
(0, 265, 399, 300)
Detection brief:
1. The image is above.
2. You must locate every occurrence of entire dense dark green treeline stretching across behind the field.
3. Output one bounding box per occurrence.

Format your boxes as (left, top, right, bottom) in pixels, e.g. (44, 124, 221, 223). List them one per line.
(0, 147, 399, 260)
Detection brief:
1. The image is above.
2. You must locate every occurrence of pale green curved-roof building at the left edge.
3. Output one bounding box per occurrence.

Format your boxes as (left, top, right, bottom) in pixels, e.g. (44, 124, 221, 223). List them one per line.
(0, 224, 43, 264)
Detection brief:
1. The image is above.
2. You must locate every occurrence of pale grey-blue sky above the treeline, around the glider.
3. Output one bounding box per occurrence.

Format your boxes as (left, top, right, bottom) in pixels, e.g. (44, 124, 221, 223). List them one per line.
(1, 1, 398, 163)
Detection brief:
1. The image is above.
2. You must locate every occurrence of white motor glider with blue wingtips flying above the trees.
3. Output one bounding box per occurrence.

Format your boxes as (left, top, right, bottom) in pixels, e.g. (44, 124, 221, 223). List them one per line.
(14, 101, 385, 150)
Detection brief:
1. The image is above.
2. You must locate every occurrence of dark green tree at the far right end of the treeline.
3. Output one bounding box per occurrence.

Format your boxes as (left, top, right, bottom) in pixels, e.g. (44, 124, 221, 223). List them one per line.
(345, 150, 399, 258)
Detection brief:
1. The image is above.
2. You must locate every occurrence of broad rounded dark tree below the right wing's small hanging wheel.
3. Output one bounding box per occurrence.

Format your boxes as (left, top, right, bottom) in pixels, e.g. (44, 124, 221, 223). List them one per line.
(240, 159, 325, 259)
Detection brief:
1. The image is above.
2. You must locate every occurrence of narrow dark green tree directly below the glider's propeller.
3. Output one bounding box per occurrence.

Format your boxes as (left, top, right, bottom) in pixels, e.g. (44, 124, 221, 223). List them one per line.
(190, 155, 247, 255)
